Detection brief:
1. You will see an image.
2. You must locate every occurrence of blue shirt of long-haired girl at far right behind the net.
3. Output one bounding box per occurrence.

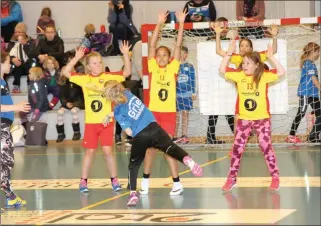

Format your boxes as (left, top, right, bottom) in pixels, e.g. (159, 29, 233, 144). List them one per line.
(298, 60, 319, 97)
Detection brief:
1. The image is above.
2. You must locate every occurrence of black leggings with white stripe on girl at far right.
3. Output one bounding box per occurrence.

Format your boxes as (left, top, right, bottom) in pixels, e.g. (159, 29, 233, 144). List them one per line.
(290, 96, 321, 138)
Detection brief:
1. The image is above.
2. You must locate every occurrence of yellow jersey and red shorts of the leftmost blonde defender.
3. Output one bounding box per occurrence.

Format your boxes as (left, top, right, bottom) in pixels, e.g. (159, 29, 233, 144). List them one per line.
(70, 72, 125, 149)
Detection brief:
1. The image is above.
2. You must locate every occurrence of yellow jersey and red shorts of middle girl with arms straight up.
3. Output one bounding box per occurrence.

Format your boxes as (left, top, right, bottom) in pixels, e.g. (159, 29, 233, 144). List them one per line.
(148, 58, 180, 136)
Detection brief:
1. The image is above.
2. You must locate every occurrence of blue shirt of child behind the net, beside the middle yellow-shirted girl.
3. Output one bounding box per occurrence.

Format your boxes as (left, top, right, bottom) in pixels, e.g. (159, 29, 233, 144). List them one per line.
(176, 63, 195, 98)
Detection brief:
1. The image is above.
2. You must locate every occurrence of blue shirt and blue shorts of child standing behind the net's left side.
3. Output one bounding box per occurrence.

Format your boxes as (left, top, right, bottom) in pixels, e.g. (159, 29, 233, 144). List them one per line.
(176, 63, 195, 111)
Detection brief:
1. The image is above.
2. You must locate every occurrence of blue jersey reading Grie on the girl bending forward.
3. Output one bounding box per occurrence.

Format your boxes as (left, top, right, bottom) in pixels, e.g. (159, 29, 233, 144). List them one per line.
(114, 90, 156, 137)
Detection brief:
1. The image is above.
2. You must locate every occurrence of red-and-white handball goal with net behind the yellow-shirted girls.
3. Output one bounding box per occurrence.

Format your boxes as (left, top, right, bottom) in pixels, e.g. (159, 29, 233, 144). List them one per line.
(142, 17, 321, 145)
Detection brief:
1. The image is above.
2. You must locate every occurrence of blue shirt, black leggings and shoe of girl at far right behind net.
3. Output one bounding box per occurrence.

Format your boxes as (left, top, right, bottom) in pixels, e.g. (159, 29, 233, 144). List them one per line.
(288, 60, 321, 143)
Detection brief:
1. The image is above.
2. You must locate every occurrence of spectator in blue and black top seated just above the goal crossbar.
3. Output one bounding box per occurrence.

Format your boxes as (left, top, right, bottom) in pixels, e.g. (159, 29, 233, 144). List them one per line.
(184, 0, 216, 22)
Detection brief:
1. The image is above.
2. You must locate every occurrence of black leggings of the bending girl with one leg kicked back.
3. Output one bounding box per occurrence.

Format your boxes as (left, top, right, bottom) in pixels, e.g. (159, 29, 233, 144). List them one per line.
(128, 122, 188, 191)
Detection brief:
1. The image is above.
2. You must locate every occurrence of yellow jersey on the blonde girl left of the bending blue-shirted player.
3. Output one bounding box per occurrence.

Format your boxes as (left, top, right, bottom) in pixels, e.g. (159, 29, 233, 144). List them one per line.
(69, 72, 125, 124)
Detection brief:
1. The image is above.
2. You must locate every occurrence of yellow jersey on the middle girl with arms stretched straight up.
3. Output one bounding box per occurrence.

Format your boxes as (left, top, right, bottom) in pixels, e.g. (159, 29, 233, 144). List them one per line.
(148, 58, 180, 112)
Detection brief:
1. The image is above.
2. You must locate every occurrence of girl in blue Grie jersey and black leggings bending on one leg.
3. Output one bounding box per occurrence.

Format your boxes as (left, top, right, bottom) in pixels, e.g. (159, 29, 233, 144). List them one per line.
(102, 81, 202, 206)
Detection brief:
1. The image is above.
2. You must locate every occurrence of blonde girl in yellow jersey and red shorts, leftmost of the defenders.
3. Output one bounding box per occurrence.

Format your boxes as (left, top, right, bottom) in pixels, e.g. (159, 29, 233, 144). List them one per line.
(62, 42, 131, 192)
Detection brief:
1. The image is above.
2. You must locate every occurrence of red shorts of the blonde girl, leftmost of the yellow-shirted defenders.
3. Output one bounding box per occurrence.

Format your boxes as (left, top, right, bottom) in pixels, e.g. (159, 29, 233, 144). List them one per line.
(82, 122, 114, 149)
